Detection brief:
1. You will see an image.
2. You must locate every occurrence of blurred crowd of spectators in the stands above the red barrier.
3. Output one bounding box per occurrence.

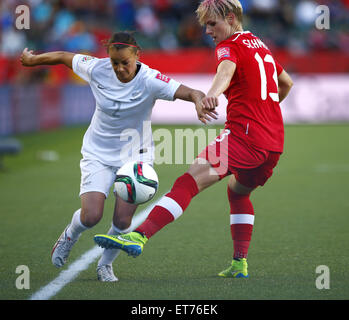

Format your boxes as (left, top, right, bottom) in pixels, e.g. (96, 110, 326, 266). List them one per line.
(0, 0, 349, 56)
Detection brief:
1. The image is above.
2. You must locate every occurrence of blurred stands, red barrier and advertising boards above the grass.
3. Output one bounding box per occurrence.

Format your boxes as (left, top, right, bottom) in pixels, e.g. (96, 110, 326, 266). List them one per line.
(0, 0, 349, 135)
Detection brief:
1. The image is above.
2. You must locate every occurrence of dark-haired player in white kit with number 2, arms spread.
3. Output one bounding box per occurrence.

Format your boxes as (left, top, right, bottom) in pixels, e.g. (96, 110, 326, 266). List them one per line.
(20, 32, 216, 281)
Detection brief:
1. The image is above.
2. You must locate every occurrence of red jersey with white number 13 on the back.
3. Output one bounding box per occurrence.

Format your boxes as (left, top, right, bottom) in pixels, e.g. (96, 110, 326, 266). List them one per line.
(216, 31, 284, 152)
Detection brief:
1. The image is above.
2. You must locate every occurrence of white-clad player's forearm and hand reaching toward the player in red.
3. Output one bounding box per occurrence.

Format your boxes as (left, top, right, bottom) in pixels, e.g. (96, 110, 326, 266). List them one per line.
(174, 84, 217, 124)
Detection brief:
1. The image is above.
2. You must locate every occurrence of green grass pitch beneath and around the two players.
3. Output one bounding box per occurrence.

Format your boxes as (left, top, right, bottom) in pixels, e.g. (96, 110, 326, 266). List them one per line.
(0, 125, 349, 300)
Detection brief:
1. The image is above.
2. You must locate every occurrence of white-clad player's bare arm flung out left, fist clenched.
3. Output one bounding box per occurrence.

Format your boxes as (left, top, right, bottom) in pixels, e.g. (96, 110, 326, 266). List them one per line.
(20, 48, 75, 69)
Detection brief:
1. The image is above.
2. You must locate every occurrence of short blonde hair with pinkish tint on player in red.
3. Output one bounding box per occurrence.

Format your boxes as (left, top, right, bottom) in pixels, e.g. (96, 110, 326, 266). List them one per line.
(196, 0, 243, 25)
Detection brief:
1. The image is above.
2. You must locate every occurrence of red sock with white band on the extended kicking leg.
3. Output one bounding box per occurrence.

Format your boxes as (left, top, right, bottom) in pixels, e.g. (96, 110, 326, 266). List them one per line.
(135, 173, 199, 239)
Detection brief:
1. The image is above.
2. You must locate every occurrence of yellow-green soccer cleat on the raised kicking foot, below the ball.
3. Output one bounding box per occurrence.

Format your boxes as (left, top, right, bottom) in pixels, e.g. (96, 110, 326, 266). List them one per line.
(94, 232, 148, 257)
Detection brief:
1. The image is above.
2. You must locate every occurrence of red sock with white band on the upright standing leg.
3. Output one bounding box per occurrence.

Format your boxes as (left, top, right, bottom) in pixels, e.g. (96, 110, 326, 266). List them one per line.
(228, 187, 254, 259)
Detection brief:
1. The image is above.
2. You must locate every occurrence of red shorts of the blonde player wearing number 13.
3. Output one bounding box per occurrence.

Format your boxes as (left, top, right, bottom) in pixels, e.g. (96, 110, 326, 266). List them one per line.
(197, 129, 281, 188)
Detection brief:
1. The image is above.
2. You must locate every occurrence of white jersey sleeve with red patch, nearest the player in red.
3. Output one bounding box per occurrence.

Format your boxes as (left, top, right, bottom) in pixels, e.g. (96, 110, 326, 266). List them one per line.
(150, 70, 181, 101)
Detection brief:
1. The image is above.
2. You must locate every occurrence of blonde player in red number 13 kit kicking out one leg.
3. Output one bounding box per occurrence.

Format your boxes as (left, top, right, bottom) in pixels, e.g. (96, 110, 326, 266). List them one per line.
(95, 0, 292, 278)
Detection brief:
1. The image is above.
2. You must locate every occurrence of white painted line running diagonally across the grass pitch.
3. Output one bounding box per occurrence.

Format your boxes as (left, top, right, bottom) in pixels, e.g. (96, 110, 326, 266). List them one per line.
(29, 204, 157, 300)
